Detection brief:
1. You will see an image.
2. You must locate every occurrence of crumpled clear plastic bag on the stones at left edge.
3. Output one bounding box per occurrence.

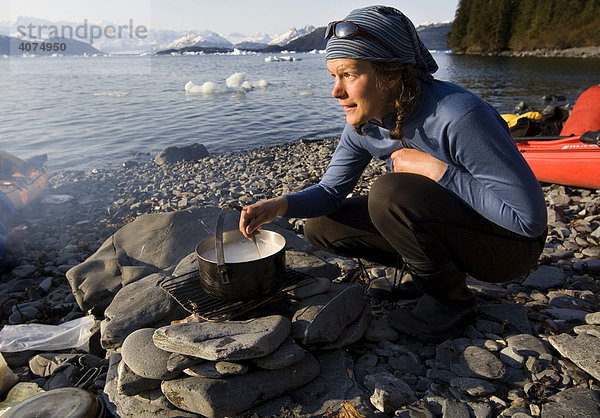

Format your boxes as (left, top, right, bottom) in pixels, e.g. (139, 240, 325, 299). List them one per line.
(0, 315, 96, 353)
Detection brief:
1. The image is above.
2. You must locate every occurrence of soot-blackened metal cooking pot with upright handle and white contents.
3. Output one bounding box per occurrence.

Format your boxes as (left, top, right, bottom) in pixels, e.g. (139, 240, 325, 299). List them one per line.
(196, 208, 285, 301)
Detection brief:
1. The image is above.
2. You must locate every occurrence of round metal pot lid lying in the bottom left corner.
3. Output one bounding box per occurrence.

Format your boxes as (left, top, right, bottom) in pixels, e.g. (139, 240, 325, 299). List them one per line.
(2, 388, 104, 418)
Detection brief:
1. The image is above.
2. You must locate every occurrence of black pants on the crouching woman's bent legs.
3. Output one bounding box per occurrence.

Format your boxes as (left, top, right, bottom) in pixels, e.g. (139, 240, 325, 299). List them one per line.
(304, 173, 546, 282)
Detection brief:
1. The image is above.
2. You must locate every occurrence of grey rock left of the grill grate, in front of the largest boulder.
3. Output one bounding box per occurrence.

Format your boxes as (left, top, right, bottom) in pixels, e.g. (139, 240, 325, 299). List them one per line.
(100, 273, 186, 349)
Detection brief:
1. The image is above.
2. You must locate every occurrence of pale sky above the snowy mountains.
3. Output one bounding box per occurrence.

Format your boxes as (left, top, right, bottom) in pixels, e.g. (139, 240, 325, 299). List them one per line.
(0, 0, 459, 35)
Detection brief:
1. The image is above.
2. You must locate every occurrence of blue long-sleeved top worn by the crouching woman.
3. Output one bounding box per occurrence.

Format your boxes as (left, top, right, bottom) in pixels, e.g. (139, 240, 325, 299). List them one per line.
(285, 80, 547, 237)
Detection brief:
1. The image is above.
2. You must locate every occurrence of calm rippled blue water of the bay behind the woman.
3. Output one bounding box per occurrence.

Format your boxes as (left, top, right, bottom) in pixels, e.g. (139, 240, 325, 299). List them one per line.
(0, 53, 600, 170)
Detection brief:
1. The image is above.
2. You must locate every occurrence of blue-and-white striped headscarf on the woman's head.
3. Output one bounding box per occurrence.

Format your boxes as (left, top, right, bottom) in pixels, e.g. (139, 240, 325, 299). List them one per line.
(325, 6, 438, 74)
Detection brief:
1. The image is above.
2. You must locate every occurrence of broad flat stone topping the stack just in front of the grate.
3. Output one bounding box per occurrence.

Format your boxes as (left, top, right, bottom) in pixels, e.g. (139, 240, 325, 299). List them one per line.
(154, 315, 291, 361)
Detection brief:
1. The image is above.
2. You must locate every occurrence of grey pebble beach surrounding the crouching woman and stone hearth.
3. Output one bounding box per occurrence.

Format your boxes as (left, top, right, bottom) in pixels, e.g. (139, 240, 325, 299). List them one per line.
(0, 140, 600, 418)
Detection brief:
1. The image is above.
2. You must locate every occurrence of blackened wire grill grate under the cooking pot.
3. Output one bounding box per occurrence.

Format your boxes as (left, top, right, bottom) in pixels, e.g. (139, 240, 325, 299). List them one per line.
(160, 268, 317, 322)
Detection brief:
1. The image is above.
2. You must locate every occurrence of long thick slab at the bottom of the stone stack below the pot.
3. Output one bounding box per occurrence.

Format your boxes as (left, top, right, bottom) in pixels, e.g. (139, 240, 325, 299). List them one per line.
(162, 354, 319, 417)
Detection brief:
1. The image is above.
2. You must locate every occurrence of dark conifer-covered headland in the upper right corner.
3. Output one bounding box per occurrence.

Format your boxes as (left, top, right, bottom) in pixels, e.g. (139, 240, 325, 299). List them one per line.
(448, 0, 600, 54)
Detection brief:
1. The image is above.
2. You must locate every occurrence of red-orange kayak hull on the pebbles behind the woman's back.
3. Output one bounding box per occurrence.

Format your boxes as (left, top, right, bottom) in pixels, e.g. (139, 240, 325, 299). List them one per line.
(515, 132, 600, 189)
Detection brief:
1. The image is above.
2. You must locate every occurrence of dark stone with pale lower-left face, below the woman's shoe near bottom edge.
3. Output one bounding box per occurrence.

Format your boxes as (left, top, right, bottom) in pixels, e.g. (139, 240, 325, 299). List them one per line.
(364, 372, 417, 414)
